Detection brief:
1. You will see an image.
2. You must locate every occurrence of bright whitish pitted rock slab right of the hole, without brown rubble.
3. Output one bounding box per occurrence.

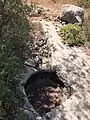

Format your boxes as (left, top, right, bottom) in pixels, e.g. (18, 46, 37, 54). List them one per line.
(42, 21, 90, 120)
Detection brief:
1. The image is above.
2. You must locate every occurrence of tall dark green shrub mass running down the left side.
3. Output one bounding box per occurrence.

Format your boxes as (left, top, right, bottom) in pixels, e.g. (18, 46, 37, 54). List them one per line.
(0, 0, 32, 120)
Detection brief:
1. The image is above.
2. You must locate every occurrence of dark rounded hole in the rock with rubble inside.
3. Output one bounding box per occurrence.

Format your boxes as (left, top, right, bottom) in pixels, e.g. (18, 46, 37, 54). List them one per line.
(24, 70, 72, 116)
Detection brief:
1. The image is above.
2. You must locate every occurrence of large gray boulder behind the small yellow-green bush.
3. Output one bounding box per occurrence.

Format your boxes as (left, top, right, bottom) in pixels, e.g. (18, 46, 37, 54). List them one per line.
(60, 4, 84, 24)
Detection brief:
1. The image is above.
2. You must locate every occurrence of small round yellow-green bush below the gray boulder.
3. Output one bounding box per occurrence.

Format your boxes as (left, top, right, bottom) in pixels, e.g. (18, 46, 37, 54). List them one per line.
(60, 24, 86, 46)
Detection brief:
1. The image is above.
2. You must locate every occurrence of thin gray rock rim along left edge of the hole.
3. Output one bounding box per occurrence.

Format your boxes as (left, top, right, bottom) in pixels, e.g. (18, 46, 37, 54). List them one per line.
(15, 64, 41, 120)
